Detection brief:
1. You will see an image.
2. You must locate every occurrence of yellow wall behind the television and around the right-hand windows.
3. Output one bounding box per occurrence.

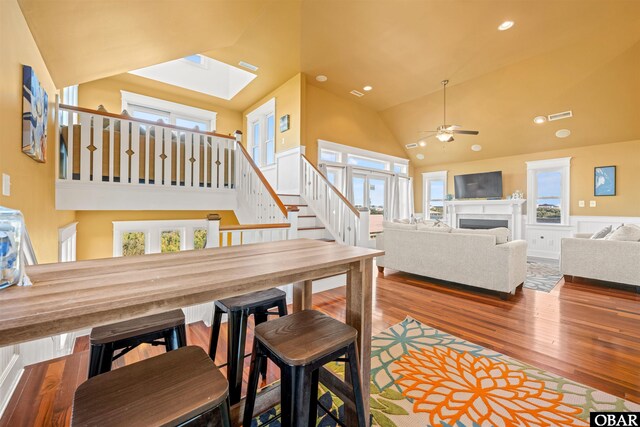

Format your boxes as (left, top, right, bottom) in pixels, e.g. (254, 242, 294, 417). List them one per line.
(414, 140, 640, 216)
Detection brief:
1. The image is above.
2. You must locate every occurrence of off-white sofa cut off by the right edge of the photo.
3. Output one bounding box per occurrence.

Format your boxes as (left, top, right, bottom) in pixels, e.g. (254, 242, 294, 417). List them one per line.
(560, 233, 640, 292)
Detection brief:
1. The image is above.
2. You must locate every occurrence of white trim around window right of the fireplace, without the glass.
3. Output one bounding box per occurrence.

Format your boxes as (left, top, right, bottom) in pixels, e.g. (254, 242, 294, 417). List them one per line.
(527, 157, 571, 227)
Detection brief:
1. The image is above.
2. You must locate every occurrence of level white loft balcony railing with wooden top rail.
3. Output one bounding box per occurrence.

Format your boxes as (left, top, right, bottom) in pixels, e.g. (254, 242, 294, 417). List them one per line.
(58, 105, 236, 190)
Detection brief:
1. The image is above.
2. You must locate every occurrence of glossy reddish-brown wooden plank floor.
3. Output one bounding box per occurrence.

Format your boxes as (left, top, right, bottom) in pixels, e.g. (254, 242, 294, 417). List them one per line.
(0, 270, 640, 427)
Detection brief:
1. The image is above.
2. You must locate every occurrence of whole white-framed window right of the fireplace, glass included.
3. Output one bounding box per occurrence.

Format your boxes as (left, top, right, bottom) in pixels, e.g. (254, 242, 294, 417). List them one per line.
(527, 157, 571, 225)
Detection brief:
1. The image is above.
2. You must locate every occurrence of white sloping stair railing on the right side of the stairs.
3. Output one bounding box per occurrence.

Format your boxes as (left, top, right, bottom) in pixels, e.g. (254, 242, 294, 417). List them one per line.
(300, 154, 369, 246)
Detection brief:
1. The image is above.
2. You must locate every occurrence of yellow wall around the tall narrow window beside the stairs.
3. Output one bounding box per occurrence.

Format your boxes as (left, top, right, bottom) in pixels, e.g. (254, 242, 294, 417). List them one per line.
(242, 73, 305, 152)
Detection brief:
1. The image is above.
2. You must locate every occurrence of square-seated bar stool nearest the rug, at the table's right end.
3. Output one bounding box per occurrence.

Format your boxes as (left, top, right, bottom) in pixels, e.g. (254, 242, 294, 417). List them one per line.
(243, 310, 366, 427)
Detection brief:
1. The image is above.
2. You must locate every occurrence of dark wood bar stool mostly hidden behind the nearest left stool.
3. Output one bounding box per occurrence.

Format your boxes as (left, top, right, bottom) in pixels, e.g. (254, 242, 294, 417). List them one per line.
(89, 309, 187, 378)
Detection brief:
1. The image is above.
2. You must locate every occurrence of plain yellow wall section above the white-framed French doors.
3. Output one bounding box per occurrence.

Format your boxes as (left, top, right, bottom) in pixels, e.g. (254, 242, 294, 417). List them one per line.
(304, 84, 407, 163)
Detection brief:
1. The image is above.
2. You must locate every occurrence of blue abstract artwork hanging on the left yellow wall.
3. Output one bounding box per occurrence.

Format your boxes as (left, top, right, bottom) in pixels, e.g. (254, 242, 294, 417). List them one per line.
(22, 65, 49, 163)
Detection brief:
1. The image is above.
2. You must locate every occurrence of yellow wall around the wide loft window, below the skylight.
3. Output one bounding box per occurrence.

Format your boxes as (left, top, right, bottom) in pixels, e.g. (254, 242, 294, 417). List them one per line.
(78, 74, 242, 135)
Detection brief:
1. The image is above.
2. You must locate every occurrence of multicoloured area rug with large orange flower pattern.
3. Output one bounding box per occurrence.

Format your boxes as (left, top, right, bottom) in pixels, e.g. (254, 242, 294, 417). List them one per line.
(253, 317, 640, 427)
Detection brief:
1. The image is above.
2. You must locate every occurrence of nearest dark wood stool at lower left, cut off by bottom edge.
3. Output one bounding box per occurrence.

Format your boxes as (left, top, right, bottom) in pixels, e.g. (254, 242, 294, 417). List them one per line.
(71, 346, 231, 427)
